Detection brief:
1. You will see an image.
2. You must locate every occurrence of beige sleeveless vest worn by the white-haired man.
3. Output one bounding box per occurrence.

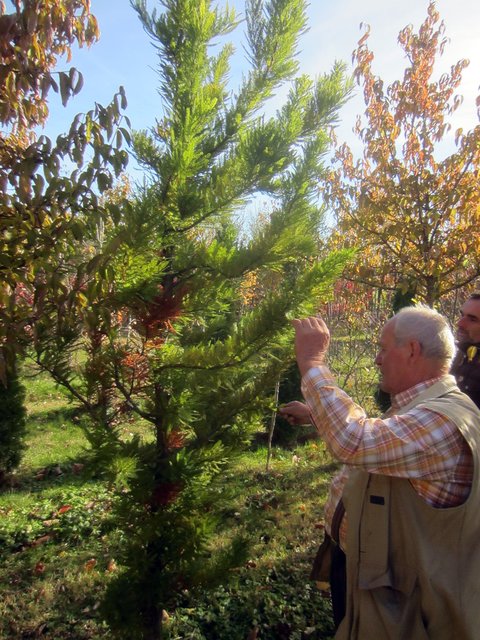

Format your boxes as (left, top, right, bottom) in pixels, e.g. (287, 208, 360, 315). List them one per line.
(335, 376, 480, 640)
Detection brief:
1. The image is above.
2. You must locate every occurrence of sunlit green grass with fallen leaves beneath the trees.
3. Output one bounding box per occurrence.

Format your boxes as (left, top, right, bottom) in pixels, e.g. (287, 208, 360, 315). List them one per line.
(0, 377, 334, 640)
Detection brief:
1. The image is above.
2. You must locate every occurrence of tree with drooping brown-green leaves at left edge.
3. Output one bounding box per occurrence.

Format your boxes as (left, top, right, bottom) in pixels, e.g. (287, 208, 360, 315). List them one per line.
(0, 0, 128, 474)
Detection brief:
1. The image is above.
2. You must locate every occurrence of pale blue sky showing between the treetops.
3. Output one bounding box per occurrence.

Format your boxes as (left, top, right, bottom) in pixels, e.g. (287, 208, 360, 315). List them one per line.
(39, 0, 480, 175)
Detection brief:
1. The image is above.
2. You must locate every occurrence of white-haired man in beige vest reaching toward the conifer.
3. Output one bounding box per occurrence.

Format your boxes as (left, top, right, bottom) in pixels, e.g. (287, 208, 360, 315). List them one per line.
(282, 307, 480, 640)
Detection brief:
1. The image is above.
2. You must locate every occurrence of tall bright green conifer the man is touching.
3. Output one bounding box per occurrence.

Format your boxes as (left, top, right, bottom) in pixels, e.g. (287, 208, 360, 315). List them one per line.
(32, 0, 350, 639)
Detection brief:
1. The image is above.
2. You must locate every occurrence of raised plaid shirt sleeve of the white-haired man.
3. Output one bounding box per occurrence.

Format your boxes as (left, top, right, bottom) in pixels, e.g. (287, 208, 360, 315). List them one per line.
(302, 367, 462, 481)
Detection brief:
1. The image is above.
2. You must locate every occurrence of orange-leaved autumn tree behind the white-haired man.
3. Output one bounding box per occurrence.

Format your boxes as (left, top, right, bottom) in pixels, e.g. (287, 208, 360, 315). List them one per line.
(325, 2, 480, 305)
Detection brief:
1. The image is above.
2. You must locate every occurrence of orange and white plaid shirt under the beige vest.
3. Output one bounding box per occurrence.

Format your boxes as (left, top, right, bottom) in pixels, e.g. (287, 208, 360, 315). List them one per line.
(302, 366, 473, 549)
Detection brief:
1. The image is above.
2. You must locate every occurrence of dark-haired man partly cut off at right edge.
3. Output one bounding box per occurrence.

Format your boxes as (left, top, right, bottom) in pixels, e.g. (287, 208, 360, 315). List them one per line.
(451, 291, 480, 407)
